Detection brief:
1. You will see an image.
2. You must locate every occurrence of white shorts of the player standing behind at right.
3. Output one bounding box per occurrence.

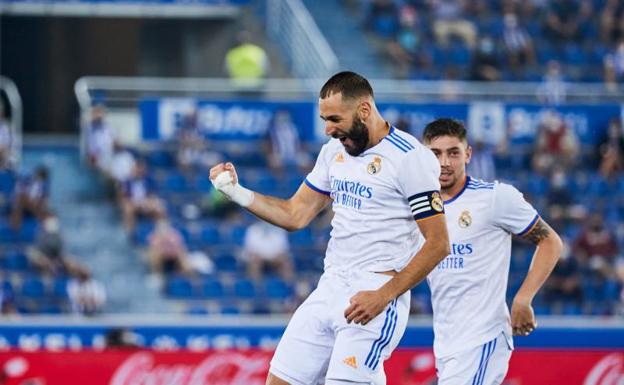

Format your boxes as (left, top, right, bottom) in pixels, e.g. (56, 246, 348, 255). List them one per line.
(436, 333, 512, 385)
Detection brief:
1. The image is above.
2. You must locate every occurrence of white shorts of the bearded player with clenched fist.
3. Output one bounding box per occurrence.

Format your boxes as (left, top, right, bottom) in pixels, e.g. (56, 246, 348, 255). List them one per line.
(271, 271, 410, 385)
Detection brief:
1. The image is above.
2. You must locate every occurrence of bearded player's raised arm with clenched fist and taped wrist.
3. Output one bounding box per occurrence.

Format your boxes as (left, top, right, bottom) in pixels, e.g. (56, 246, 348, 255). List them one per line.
(210, 163, 331, 231)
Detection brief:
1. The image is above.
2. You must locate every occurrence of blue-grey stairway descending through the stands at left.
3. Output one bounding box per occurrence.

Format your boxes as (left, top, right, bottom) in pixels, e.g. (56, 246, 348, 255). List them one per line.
(21, 138, 173, 313)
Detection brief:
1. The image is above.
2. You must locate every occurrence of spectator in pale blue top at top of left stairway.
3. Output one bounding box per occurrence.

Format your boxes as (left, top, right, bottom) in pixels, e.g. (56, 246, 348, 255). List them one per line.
(87, 105, 115, 171)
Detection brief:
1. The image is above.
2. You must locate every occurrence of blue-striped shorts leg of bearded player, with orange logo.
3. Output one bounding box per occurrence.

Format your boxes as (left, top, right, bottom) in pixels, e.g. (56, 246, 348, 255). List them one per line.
(325, 292, 410, 385)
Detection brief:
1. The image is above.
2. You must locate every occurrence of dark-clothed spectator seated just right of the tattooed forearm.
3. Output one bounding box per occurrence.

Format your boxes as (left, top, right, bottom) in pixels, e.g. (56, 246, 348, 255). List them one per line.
(544, 244, 583, 306)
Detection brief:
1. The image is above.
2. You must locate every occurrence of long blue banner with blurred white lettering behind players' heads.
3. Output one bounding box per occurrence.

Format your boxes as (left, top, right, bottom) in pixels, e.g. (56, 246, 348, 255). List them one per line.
(140, 98, 621, 145)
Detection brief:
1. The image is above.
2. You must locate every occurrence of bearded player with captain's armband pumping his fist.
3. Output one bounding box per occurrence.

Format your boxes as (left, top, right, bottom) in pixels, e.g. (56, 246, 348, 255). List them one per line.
(210, 72, 449, 385)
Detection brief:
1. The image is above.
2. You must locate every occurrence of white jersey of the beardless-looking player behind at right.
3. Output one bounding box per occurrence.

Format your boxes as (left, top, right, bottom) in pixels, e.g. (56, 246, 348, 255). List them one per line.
(427, 177, 539, 358)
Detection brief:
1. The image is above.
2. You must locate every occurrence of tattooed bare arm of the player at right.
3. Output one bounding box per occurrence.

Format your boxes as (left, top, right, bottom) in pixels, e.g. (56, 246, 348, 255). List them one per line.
(511, 218, 563, 335)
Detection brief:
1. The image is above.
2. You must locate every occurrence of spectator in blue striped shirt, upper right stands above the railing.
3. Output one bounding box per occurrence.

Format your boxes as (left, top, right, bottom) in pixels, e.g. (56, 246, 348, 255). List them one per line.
(503, 12, 535, 71)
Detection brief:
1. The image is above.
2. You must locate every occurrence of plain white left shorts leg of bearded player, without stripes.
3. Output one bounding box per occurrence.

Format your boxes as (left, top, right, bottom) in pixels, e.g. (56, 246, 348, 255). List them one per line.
(270, 276, 334, 385)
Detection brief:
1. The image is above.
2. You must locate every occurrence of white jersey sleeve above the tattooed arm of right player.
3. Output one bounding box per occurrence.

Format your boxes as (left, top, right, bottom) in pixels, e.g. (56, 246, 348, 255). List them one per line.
(494, 183, 539, 236)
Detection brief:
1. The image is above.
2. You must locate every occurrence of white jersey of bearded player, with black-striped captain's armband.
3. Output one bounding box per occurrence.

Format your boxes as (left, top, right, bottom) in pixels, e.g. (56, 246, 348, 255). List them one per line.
(305, 127, 444, 271)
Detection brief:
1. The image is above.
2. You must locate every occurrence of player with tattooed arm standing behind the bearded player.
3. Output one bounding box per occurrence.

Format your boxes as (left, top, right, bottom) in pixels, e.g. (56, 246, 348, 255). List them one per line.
(423, 119, 562, 385)
